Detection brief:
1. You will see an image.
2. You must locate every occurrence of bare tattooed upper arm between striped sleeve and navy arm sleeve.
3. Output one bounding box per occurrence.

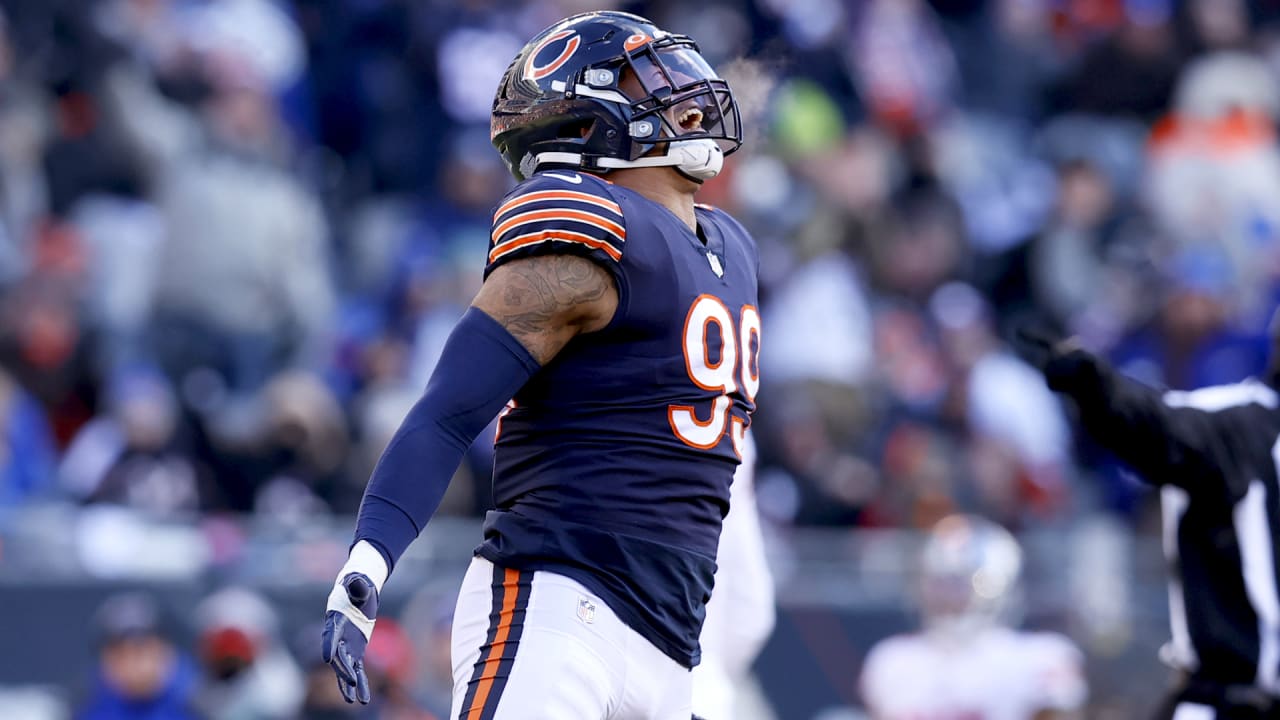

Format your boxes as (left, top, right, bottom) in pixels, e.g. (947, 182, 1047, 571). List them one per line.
(474, 255, 618, 365)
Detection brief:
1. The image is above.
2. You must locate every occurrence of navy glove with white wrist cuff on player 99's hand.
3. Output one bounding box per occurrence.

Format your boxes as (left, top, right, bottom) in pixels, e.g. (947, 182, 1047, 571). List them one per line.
(320, 573, 378, 705)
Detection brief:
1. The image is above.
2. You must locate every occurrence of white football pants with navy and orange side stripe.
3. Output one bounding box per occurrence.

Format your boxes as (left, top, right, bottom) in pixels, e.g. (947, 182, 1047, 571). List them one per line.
(449, 557, 692, 720)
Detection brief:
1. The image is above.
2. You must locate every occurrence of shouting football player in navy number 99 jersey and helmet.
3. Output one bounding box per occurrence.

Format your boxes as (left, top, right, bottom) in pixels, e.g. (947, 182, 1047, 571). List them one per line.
(324, 12, 760, 720)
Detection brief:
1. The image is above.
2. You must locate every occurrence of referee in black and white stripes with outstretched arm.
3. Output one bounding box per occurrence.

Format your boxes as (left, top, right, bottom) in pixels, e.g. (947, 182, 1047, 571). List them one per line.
(1018, 325, 1280, 720)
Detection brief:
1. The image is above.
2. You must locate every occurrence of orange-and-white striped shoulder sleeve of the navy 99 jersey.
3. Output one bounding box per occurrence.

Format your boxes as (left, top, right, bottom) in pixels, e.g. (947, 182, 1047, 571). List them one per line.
(489, 170, 627, 265)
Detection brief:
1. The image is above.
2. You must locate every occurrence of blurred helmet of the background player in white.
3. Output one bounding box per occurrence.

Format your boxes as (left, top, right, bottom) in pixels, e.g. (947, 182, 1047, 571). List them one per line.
(919, 515, 1023, 634)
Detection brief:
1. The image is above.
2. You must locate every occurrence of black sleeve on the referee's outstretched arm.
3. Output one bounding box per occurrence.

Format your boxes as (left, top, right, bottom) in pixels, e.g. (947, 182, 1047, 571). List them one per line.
(1046, 350, 1235, 489)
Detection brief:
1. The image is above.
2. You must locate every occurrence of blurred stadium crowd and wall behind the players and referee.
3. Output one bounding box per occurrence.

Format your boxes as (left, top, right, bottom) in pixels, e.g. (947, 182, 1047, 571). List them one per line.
(0, 0, 1280, 720)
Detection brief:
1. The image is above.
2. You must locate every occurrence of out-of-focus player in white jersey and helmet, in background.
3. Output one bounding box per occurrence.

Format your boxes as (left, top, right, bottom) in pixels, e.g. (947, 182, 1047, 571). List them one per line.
(861, 515, 1087, 720)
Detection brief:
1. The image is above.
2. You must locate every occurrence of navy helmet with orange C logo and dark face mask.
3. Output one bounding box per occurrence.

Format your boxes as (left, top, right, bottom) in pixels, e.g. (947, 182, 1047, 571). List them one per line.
(490, 12, 742, 182)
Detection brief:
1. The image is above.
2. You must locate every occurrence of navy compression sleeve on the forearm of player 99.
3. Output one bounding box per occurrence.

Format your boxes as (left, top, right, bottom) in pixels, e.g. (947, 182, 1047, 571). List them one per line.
(355, 307, 539, 568)
